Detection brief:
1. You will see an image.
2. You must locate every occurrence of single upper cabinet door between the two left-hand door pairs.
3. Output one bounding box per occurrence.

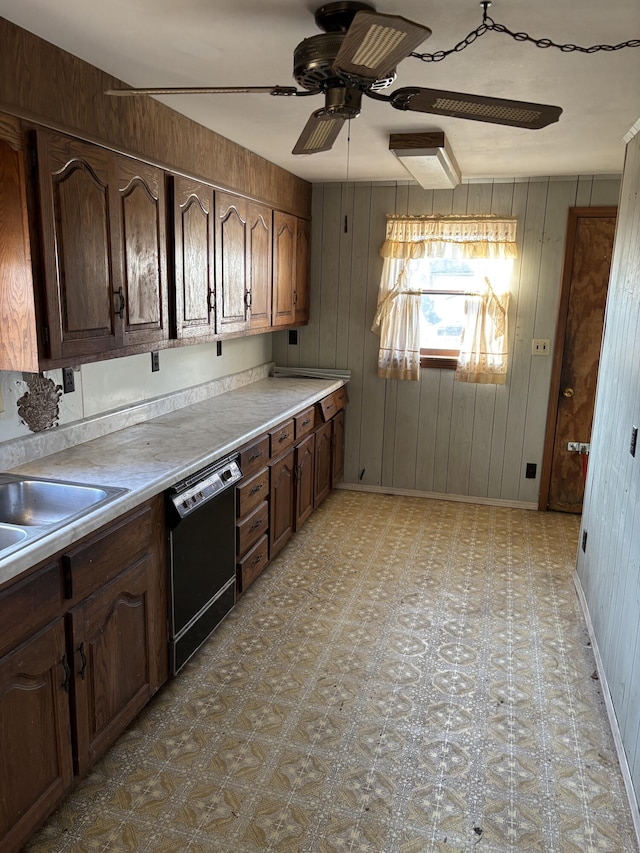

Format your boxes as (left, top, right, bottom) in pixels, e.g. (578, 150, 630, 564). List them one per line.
(172, 176, 215, 338)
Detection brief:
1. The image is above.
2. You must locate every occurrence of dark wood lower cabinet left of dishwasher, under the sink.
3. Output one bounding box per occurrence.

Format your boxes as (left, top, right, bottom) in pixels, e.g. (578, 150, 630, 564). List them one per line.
(0, 497, 168, 853)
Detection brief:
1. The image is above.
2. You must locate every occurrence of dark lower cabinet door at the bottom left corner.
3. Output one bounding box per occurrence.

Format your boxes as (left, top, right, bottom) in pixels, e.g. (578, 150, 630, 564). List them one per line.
(0, 619, 73, 851)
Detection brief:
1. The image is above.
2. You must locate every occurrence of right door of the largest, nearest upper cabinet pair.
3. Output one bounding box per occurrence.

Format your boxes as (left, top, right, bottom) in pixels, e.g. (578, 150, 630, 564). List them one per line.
(114, 155, 169, 346)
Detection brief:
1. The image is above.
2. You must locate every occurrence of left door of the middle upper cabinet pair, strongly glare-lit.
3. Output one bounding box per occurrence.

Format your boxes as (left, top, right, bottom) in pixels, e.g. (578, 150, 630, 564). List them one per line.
(216, 192, 249, 335)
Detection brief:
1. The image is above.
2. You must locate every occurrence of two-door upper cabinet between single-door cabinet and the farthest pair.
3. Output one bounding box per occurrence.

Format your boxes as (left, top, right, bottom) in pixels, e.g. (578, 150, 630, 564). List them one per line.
(216, 192, 272, 335)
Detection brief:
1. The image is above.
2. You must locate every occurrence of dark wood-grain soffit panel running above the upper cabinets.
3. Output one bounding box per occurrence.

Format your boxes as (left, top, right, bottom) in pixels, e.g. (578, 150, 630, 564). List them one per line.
(0, 18, 311, 218)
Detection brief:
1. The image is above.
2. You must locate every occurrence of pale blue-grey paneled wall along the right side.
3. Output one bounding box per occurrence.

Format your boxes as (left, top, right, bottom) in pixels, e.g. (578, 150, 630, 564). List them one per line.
(578, 128, 640, 797)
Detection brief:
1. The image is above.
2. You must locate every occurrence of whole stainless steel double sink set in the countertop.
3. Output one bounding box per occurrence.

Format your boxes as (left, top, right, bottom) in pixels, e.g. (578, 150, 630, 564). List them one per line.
(0, 474, 127, 558)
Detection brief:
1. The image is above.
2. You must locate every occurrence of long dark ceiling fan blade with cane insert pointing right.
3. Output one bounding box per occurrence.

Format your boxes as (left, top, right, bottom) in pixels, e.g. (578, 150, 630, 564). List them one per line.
(390, 87, 562, 130)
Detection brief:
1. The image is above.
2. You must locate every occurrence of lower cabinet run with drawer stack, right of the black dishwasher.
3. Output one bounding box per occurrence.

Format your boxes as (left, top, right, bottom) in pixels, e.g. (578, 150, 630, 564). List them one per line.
(236, 388, 348, 593)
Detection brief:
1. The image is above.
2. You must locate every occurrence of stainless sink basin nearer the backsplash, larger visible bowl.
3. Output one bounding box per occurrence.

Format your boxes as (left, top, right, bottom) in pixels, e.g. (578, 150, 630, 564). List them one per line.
(0, 480, 112, 527)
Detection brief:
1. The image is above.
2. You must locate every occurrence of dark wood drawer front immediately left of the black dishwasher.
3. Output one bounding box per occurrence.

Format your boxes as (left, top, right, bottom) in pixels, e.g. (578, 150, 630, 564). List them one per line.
(62, 505, 153, 599)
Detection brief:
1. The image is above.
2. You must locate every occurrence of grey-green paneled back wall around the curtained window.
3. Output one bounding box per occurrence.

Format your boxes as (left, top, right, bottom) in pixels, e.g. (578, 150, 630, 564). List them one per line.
(274, 176, 620, 504)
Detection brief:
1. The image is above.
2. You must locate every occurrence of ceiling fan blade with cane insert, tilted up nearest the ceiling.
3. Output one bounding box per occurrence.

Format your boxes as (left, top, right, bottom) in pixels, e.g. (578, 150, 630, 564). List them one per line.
(333, 12, 431, 82)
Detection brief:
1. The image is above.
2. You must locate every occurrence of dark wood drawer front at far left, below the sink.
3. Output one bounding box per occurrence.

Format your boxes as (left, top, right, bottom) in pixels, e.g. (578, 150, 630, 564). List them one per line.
(0, 561, 63, 655)
